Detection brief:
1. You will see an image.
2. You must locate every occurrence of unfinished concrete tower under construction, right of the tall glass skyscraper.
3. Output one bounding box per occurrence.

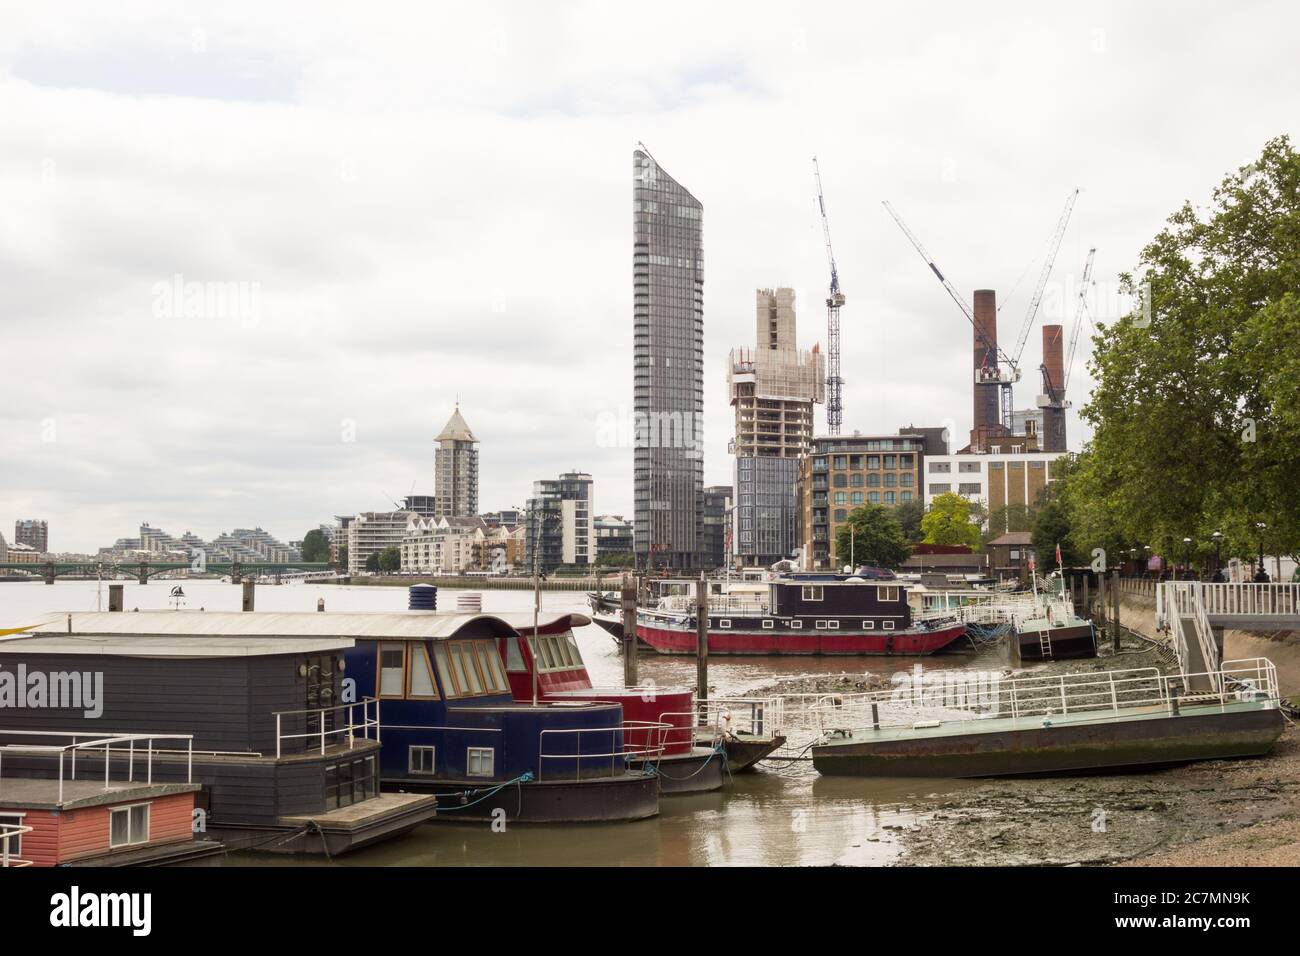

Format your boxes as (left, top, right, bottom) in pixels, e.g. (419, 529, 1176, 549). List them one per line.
(727, 289, 826, 566)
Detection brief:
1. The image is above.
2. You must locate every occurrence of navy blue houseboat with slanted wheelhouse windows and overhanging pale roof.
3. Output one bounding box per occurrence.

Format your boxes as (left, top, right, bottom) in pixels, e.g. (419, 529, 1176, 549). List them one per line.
(338, 606, 664, 823)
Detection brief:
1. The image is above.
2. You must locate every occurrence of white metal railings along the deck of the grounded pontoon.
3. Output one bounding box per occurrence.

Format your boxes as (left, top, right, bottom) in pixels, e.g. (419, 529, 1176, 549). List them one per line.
(814, 658, 1279, 739)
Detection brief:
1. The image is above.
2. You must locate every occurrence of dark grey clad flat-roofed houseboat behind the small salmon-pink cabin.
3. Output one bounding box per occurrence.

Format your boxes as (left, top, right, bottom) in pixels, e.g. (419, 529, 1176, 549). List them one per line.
(0, 610, 437, 856)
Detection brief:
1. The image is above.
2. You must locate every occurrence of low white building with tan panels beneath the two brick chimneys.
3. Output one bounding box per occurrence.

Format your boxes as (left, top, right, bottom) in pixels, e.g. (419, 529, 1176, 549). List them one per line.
(926, 447, 1067, 528)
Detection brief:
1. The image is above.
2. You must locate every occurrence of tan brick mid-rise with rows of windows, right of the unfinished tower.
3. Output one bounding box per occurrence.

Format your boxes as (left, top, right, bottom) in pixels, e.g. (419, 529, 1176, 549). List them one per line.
(800, 433, 926, 570)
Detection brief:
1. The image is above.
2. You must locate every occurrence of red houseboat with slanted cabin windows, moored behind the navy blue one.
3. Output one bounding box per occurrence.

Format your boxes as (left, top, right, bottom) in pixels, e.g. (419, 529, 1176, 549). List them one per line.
(501, 614, 733, 793)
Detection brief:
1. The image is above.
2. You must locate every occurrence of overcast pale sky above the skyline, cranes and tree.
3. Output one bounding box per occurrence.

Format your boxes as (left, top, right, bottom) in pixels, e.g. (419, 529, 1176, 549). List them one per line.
(0, 0, 1300, 550)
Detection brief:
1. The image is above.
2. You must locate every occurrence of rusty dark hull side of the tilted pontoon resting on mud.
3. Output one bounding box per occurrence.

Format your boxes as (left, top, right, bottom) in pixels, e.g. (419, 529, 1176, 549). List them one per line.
(813, 708, 1283, 778)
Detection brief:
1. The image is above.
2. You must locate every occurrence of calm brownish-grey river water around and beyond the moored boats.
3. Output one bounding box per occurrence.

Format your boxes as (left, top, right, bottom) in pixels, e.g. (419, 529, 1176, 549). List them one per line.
(0, 580, 969, 866)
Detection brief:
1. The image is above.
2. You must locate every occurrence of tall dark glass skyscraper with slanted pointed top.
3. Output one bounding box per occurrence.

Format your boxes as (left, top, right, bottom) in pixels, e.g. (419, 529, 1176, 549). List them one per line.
(632, 150, 705, 568)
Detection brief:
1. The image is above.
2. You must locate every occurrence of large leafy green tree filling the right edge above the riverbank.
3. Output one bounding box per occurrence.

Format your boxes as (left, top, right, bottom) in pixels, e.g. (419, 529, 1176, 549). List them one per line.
(1062, 137, 1300, 566)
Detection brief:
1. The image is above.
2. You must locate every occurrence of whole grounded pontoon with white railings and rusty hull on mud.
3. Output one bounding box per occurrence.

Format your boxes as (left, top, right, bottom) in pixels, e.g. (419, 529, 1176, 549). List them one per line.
(813, 658, 1284, 778)
